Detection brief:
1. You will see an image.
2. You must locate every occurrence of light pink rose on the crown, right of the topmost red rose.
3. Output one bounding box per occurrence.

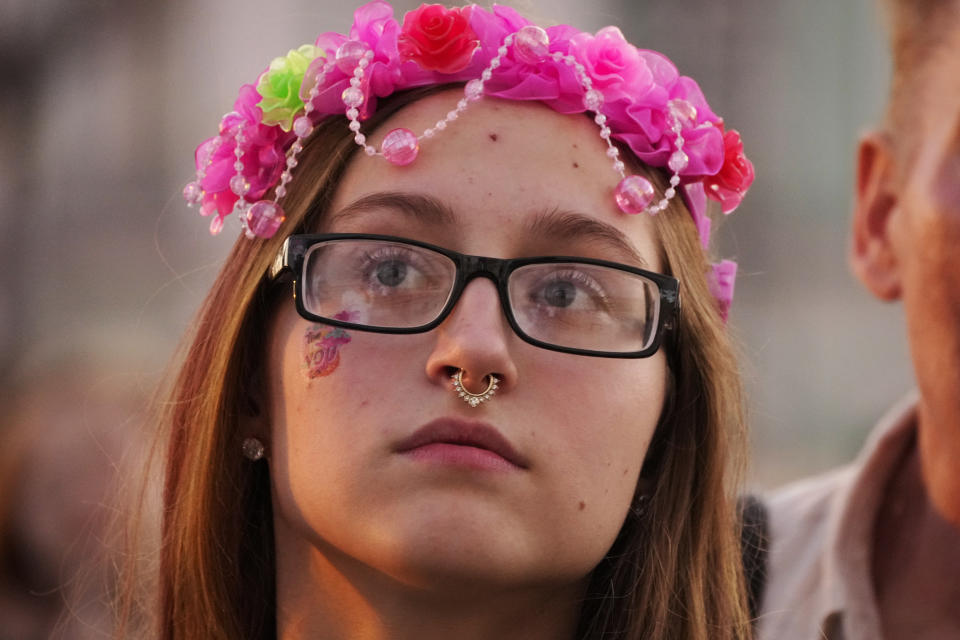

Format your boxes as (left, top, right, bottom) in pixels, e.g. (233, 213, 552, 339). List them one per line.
(570, 27, 653, 102)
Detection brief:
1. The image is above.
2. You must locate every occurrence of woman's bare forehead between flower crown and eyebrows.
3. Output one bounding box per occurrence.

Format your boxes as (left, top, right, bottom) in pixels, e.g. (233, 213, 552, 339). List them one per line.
(331, 90, 657, 264)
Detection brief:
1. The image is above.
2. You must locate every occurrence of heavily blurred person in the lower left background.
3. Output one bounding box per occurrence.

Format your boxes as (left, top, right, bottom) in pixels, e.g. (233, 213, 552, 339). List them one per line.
(0, 356, 144, 640)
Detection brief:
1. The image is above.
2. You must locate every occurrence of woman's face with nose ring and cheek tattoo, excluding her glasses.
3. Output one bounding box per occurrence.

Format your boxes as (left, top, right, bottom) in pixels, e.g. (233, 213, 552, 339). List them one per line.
(265, 91, 668, 589)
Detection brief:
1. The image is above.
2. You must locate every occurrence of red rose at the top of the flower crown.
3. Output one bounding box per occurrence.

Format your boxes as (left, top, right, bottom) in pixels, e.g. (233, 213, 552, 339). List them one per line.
(397, 4, 480, 73)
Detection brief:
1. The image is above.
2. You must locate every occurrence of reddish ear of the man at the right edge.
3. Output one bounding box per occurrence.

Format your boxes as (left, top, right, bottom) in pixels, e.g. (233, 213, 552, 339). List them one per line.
(850, 132, 901, 300)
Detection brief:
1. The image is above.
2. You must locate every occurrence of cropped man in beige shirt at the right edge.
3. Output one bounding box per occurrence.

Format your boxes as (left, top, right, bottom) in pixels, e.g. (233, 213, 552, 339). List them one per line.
(759, 0, 960, 640)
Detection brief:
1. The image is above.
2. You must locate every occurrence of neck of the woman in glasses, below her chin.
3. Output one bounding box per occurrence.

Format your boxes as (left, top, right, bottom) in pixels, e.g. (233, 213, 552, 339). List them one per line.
(277, 524, 582, 640)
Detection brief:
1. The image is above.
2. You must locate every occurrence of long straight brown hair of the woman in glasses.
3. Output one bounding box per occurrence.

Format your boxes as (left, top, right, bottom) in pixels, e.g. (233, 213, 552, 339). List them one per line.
(118, 87, 749, 640)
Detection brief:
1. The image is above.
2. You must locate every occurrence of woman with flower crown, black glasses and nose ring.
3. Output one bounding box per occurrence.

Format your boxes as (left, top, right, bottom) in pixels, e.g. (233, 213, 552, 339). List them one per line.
(118, 2, 753, 640)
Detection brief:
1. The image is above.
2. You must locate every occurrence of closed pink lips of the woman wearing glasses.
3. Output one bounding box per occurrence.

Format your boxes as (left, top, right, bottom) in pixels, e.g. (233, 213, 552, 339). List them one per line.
(394, 418, 529, 470)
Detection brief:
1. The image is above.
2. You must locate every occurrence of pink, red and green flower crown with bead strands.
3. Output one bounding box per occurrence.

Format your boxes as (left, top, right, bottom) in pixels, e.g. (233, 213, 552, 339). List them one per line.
(184, 0, 754, 315)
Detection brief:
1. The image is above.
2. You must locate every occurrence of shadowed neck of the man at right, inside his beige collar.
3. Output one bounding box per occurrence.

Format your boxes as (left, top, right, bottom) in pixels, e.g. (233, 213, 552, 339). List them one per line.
(873, 438, 960, 640)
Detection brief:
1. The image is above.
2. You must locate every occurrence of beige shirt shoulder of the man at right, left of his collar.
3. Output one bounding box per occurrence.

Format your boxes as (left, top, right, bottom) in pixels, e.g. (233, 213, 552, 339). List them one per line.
(757, 465, 857, 640)
